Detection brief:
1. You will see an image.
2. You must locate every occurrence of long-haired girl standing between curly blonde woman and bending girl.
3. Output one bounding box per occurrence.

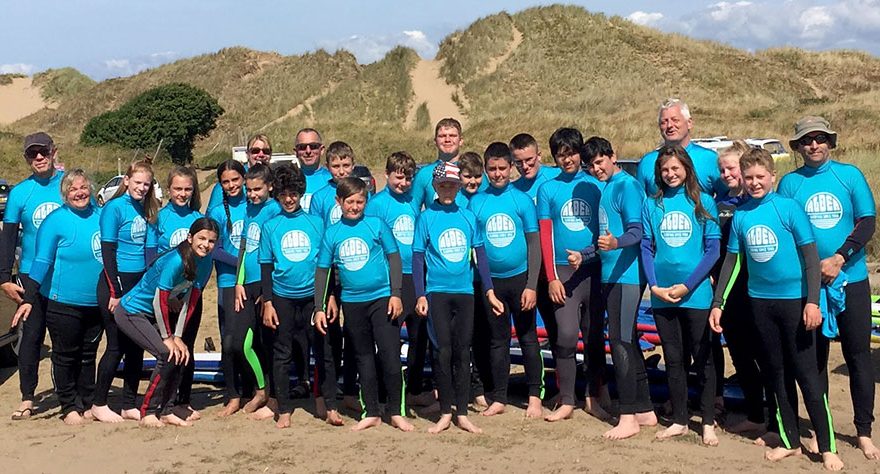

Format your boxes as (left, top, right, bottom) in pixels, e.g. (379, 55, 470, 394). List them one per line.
(92, 162, 159, 423)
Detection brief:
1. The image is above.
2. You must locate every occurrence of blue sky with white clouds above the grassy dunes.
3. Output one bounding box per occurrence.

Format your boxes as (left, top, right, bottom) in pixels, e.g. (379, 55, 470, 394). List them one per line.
(0, 0, 880, 79)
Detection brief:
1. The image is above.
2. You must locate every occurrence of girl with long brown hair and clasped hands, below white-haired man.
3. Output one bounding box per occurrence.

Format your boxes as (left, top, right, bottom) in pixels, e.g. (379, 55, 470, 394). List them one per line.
(641, 145, 721, 446)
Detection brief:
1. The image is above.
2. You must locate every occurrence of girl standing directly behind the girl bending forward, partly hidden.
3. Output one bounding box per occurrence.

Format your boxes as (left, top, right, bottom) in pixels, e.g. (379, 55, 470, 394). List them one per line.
(147, 166, 204, 420)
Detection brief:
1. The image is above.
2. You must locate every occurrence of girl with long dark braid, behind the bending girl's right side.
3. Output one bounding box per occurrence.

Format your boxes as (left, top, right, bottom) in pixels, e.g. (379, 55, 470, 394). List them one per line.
(208, 160, 253, 417)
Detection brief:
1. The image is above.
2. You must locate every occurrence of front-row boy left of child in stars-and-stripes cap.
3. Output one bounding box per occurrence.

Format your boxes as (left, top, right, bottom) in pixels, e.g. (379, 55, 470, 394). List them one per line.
(315, 178, 414, 431)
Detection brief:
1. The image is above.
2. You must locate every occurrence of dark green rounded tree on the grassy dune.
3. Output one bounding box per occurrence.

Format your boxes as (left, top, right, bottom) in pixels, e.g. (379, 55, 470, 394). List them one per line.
(80, 83, 223, 165)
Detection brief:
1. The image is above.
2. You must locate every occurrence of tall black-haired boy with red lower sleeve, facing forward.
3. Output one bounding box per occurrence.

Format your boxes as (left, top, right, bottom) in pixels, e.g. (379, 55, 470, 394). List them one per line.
(538, 128, 610, 422)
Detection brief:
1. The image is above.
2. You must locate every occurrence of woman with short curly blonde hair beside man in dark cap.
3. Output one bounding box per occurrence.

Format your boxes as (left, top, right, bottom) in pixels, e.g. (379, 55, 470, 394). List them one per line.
(14, 169, 102, 425)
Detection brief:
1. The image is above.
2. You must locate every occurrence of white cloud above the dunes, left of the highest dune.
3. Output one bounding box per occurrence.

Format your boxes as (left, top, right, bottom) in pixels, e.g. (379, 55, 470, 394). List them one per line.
(318, 30, 437, 64)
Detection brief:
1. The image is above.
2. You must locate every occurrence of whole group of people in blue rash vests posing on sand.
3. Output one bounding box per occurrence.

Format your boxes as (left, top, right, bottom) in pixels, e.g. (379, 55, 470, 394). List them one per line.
(0, 99, 880, 470)
